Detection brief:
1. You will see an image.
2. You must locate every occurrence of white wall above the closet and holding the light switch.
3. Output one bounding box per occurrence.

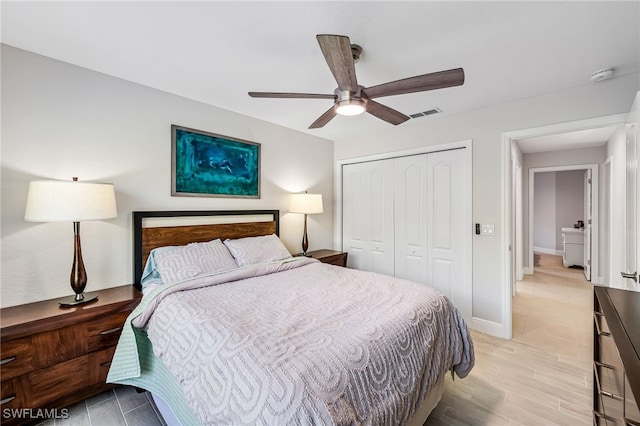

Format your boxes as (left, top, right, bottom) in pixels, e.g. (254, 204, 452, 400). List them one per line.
(334, 73, 640, 335)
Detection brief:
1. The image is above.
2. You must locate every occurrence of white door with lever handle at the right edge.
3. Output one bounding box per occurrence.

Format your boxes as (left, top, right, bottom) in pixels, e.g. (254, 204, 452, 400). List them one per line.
(621, 92, 640, 290)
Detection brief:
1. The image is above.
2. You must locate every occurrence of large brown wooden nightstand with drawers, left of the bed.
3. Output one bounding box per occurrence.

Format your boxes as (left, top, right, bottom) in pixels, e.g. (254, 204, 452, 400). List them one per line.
(0, 285, 142, 424)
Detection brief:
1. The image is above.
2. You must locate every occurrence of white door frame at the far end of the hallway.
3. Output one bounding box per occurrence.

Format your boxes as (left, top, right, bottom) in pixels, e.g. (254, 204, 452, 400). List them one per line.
(527, 164, 600, 283)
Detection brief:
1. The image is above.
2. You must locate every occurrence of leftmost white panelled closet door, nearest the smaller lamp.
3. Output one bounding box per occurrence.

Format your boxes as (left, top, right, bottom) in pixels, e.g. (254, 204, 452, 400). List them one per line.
(342, 160, 394, 275)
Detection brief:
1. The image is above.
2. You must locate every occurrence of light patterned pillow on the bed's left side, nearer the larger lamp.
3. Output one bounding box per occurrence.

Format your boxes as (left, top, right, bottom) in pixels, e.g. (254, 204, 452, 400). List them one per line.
(153, 239, 238, 284)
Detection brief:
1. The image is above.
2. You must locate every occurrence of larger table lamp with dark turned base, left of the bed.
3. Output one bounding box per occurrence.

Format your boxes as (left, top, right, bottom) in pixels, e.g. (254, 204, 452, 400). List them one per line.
(24, 177, 118, 307)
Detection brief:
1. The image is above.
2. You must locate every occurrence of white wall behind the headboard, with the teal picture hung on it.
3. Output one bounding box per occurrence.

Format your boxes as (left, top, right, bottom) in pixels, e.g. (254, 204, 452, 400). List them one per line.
(0, 45, 334, 307)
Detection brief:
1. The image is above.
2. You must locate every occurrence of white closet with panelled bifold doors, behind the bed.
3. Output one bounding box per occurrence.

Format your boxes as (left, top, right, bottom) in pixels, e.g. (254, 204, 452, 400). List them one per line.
(342, 148, 472, 319)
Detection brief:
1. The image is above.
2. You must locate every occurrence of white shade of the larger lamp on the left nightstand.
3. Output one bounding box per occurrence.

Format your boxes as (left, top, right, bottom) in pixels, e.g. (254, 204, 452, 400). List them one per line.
(24, 180, 118, 222)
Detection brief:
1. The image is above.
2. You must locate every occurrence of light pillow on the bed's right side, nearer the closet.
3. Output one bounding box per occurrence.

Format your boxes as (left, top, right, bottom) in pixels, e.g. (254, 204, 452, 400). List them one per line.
(224, 234, 291, 266)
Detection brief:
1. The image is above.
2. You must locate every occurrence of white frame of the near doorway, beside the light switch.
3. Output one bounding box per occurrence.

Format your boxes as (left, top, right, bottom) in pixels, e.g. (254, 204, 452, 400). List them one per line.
(499, 113, 628, 339)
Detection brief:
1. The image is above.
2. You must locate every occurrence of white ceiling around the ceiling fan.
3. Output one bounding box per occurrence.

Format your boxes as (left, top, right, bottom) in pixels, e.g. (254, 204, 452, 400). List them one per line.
(1, 1, 640, 140)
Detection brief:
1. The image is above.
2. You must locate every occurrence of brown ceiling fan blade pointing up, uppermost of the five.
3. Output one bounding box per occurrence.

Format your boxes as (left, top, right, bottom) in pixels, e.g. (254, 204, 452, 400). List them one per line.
(316, 34, 358, 92)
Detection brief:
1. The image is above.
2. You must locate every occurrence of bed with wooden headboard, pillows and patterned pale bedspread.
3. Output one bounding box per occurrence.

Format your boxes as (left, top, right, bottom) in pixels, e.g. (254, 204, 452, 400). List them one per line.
(107, 210, 474, 425)
